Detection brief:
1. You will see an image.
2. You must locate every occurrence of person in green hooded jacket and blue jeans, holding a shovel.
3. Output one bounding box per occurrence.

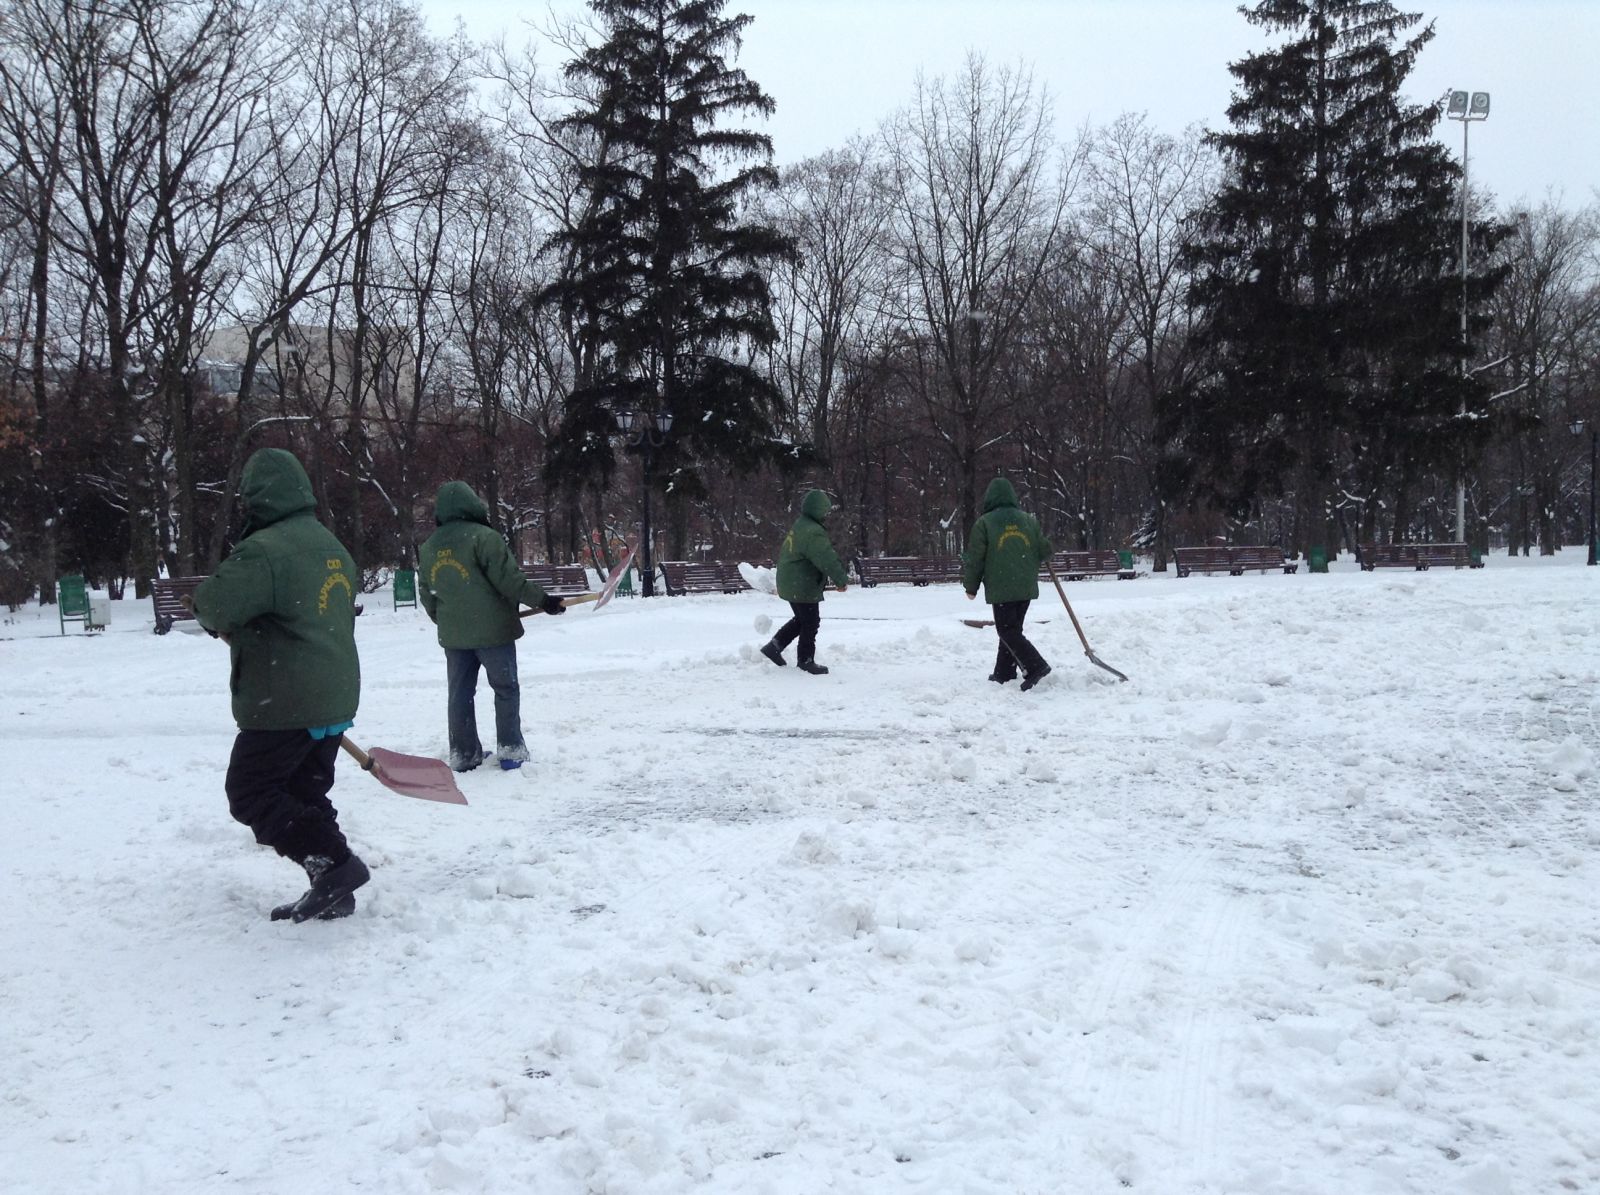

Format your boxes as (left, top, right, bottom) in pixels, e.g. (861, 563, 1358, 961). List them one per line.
(418, 482, 566, 771)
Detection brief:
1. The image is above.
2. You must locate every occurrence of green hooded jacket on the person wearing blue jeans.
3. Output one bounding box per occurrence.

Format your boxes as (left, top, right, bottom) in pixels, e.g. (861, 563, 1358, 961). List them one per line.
(416, 482, 546, 648)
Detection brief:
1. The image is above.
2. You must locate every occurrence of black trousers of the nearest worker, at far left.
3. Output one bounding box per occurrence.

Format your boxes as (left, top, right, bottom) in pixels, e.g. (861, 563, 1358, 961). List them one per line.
(227, 729, 350, 864)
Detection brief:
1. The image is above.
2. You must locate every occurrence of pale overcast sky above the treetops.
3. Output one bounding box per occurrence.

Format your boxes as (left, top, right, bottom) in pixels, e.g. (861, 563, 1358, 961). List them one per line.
(421, 0, 1600, 206)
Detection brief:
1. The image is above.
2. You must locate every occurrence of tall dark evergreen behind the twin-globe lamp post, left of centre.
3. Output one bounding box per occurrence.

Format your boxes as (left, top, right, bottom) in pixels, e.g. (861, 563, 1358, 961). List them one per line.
(547, 0, 794, 498)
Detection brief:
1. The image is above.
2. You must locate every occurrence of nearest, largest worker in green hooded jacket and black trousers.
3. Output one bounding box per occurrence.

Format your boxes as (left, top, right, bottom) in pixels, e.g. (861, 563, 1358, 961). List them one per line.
(194, 448, 370, 921)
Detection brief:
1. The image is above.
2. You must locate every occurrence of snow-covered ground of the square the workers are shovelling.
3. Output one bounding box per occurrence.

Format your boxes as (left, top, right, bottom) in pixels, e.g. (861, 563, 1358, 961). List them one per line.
(0, 550, 1600, 1195)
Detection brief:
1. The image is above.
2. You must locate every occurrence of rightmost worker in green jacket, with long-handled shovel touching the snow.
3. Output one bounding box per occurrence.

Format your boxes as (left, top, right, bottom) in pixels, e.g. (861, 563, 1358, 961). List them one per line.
(962, 477, 1051, 689)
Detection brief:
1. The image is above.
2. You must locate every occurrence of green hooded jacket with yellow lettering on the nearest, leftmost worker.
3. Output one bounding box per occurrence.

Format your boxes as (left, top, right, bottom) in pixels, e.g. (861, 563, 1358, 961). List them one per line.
(195, 448, 362, 729)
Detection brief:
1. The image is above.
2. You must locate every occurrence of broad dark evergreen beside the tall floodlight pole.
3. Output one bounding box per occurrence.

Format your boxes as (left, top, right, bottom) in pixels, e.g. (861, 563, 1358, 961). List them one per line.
(1158, 0, 1494, 547)
